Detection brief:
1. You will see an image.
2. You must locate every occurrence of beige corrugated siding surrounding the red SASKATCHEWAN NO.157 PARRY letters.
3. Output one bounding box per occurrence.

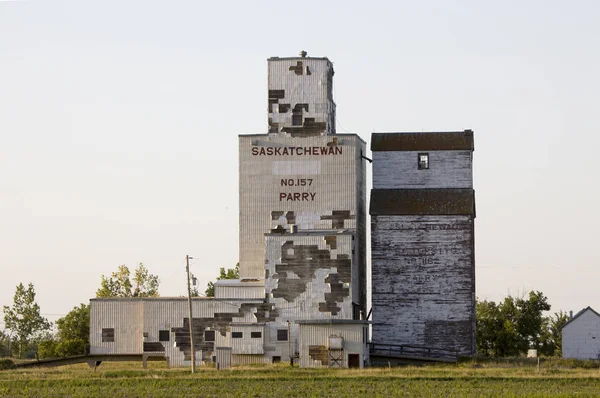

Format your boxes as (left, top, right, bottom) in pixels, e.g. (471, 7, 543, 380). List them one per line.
(239, 134, 364, 278)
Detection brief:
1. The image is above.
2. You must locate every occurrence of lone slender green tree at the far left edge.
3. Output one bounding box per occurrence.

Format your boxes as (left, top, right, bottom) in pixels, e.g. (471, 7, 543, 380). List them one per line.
(4, 283, 52, 357)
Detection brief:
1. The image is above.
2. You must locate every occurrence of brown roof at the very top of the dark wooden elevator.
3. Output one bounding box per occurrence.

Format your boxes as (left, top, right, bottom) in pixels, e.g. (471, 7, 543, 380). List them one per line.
(371, 130, 475, 152)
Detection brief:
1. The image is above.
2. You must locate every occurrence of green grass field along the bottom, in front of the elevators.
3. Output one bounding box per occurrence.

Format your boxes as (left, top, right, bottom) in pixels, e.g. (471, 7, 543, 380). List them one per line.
(0, 361, 600, 398)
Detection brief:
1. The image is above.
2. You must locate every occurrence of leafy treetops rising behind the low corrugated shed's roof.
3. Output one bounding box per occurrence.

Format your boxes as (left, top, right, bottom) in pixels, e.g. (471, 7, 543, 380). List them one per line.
(96, 263, 160, 297)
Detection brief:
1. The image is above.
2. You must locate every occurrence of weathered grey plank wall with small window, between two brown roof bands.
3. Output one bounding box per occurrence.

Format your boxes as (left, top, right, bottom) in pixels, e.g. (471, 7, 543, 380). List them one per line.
(373, 150, 473, 189)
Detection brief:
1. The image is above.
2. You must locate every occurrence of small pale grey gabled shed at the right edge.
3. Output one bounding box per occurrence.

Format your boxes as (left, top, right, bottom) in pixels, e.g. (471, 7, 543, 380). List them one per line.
(562, 308, 600, 359)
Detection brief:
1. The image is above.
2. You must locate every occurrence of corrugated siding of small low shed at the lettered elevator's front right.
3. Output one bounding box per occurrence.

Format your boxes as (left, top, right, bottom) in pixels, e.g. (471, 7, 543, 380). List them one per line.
(300, 324, 368, 368)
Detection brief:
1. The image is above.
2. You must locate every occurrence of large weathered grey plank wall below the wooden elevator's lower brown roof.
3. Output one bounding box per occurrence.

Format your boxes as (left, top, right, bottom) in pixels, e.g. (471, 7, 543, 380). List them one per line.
(371, 215, 475, 355)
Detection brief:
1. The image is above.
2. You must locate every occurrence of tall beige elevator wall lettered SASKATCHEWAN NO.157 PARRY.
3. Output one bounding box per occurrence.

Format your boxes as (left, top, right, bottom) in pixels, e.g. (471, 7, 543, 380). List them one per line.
(239, 134, 366, 279)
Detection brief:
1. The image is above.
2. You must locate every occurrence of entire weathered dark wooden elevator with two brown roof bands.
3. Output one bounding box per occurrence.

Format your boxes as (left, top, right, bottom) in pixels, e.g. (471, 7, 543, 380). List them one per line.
(370, 130, 475, 356)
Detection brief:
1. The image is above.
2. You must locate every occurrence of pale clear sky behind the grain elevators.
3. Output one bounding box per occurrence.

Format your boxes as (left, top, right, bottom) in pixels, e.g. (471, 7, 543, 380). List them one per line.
(0, 0, 600, 330)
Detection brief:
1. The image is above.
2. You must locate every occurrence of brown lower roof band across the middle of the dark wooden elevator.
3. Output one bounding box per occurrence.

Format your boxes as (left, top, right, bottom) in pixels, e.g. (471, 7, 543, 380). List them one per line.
(370, 189, 475, 216)
